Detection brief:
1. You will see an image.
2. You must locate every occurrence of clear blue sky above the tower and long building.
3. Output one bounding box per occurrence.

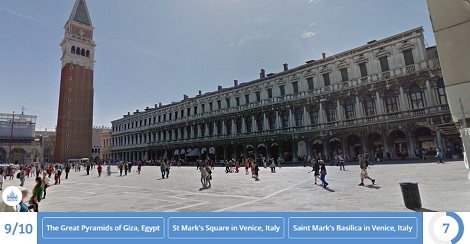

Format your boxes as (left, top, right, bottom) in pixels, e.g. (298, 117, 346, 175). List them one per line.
(0, 0, 435, 129)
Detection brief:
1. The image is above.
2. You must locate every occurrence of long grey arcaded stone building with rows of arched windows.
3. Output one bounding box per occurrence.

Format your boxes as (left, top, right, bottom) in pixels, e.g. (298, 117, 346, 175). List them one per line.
(111, 27, 461, 161)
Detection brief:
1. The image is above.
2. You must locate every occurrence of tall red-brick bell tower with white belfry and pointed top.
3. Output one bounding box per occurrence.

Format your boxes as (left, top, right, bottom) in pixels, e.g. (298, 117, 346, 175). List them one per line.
(54, 0, 96, 162)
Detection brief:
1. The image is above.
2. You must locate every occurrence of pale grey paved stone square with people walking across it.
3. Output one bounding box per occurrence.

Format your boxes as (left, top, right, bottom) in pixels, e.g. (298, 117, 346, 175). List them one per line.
(0, 161, 470, 212)
